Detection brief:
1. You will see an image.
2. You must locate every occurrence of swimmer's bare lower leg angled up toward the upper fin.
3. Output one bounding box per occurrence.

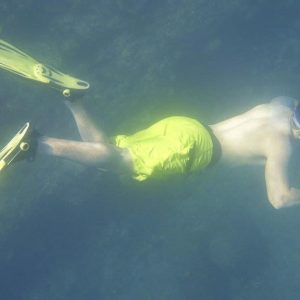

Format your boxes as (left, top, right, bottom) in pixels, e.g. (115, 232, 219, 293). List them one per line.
(65, 101, 107, 143)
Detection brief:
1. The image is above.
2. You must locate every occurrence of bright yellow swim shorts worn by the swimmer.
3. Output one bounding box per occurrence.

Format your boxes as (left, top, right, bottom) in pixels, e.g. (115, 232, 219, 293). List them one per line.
(114, 117, 213, 181)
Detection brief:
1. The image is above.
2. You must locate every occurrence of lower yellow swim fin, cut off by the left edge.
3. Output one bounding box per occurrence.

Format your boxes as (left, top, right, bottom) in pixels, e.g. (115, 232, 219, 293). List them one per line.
(0, 122, 31, 172)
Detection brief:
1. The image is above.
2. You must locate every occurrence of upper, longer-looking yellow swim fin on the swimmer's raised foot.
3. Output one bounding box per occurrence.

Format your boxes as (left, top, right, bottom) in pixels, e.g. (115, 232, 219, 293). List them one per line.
(0, 40, 90, 97)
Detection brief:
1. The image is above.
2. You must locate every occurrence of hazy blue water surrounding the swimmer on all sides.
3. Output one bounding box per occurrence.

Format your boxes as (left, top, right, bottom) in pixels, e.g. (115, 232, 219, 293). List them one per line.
(0, 0, 300, 300)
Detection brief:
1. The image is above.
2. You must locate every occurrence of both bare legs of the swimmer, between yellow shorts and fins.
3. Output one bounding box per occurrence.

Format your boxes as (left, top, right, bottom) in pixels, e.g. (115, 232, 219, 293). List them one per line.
(33, 101, 132, 173)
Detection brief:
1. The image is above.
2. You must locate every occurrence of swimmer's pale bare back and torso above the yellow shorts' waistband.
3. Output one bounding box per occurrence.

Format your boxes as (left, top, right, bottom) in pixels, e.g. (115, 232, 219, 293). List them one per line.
(210, 103, 292, 164)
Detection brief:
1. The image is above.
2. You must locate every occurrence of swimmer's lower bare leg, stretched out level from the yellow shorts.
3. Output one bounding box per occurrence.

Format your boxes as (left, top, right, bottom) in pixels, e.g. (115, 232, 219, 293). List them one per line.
(37, 136, 132, 173)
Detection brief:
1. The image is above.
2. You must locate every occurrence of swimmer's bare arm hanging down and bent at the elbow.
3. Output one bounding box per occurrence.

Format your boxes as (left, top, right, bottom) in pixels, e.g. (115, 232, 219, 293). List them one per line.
(265, 137, 300, 209)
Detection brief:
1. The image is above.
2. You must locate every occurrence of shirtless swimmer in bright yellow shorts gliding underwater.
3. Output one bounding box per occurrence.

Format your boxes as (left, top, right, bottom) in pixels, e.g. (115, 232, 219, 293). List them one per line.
(0, 97, 300, 209)
